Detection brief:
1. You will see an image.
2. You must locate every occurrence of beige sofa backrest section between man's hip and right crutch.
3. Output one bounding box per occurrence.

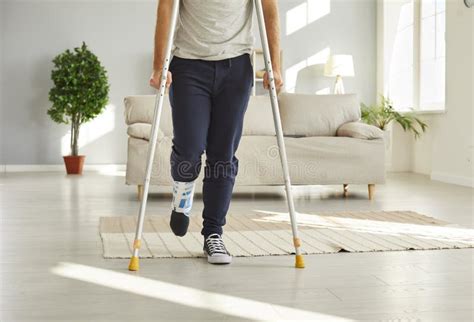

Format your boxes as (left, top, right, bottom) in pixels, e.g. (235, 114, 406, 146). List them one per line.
(243, 95, 275, 135)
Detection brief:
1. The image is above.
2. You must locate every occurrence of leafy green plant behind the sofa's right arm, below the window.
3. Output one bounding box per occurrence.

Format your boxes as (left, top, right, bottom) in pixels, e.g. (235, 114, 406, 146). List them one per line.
(361, 95, 428, 139)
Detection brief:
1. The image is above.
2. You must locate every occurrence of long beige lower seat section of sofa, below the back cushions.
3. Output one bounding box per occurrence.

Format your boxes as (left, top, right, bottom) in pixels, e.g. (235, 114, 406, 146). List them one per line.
(126, 136, 385, 186)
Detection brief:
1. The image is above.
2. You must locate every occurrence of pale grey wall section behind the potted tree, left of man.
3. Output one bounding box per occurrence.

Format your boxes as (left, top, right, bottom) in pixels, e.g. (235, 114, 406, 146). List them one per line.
(0, 1, 156, 164)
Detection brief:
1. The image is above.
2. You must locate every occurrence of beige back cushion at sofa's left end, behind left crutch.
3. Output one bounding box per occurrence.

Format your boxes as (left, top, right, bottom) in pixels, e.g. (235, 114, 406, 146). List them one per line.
(124, 95, 173, 136)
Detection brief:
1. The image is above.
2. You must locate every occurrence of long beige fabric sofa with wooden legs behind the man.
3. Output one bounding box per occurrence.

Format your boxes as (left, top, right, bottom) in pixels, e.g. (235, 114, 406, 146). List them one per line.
(124, 93, 385, 199)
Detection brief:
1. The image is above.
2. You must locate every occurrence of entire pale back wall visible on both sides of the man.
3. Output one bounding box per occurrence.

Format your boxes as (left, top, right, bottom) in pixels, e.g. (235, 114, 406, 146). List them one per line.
(0, 0, 376, 164)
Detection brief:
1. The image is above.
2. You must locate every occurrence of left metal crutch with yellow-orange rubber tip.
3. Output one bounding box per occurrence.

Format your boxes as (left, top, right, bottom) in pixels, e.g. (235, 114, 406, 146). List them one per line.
(128, 0, 180, 271)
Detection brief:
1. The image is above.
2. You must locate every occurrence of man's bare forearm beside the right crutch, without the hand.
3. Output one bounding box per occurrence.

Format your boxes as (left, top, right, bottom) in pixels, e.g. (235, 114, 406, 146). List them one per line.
(262, 0, 281, 72)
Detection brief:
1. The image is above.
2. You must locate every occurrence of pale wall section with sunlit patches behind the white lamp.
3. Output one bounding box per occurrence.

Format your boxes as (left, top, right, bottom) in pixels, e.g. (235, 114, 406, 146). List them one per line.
(276, 0, 377, 104)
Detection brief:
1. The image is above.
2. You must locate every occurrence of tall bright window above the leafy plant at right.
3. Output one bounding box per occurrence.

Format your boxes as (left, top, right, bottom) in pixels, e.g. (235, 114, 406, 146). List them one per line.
(383, 0, 446, 110)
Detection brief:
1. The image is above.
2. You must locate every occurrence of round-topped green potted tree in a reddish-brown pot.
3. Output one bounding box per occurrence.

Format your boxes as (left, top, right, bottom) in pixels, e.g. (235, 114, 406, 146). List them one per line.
(48, 42, 110, 174)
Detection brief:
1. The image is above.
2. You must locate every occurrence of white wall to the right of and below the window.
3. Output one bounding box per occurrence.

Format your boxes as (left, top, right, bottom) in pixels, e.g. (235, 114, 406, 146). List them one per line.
(386, 0, 474, 186)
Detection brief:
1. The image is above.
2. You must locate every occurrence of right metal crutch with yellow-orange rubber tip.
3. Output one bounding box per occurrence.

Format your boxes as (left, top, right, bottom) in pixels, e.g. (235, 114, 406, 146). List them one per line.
(254, 0, 304, 268)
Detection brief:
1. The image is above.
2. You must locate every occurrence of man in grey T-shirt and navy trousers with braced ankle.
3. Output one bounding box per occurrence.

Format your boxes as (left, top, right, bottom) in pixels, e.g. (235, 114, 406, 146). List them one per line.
(150, 0, 283, 264)
